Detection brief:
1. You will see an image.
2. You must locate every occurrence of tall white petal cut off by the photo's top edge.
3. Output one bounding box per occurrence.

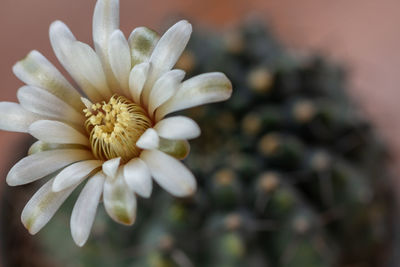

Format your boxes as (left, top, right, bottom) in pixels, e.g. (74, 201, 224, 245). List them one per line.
(93, 0, 121, 94)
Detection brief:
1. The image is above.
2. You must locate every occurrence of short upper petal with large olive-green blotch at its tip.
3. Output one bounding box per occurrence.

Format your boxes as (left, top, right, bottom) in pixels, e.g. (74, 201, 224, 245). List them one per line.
(128, 27, 160, 66)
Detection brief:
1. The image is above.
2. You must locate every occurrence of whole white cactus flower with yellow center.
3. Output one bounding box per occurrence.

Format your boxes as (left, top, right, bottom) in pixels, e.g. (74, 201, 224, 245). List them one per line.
(0, 0, 232, 246)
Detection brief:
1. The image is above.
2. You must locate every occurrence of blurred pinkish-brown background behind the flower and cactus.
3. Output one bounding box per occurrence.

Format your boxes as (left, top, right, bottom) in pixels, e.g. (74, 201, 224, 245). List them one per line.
(0, 0, 400, 266)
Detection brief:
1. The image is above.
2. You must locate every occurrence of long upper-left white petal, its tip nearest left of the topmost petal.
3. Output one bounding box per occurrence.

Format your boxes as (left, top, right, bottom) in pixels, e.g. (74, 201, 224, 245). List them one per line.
(50, 21, 102, 102)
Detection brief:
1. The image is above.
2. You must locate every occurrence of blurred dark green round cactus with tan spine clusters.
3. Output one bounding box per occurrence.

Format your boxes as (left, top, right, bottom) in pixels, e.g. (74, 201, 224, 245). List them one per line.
(3, 22, 393, 267)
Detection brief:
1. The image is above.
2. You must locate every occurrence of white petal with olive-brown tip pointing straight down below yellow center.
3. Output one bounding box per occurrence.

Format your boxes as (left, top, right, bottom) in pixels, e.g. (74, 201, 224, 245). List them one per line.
(103, 170, 136, 225)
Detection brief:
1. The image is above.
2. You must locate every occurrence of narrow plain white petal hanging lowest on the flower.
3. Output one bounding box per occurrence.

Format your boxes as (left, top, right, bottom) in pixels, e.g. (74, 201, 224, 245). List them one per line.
(71, 172, 106, 247)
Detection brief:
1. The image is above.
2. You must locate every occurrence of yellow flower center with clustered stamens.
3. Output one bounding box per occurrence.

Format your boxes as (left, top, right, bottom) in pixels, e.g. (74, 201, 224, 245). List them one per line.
(83, 95, 152, 162)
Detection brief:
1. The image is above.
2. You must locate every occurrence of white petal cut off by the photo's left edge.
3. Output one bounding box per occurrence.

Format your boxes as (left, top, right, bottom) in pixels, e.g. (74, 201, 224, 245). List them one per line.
(0, 102, 42, 133)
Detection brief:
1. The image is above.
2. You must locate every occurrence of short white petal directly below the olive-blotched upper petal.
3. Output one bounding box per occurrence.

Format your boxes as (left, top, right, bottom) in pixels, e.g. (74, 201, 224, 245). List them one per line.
(129, 62, 150, 104)
